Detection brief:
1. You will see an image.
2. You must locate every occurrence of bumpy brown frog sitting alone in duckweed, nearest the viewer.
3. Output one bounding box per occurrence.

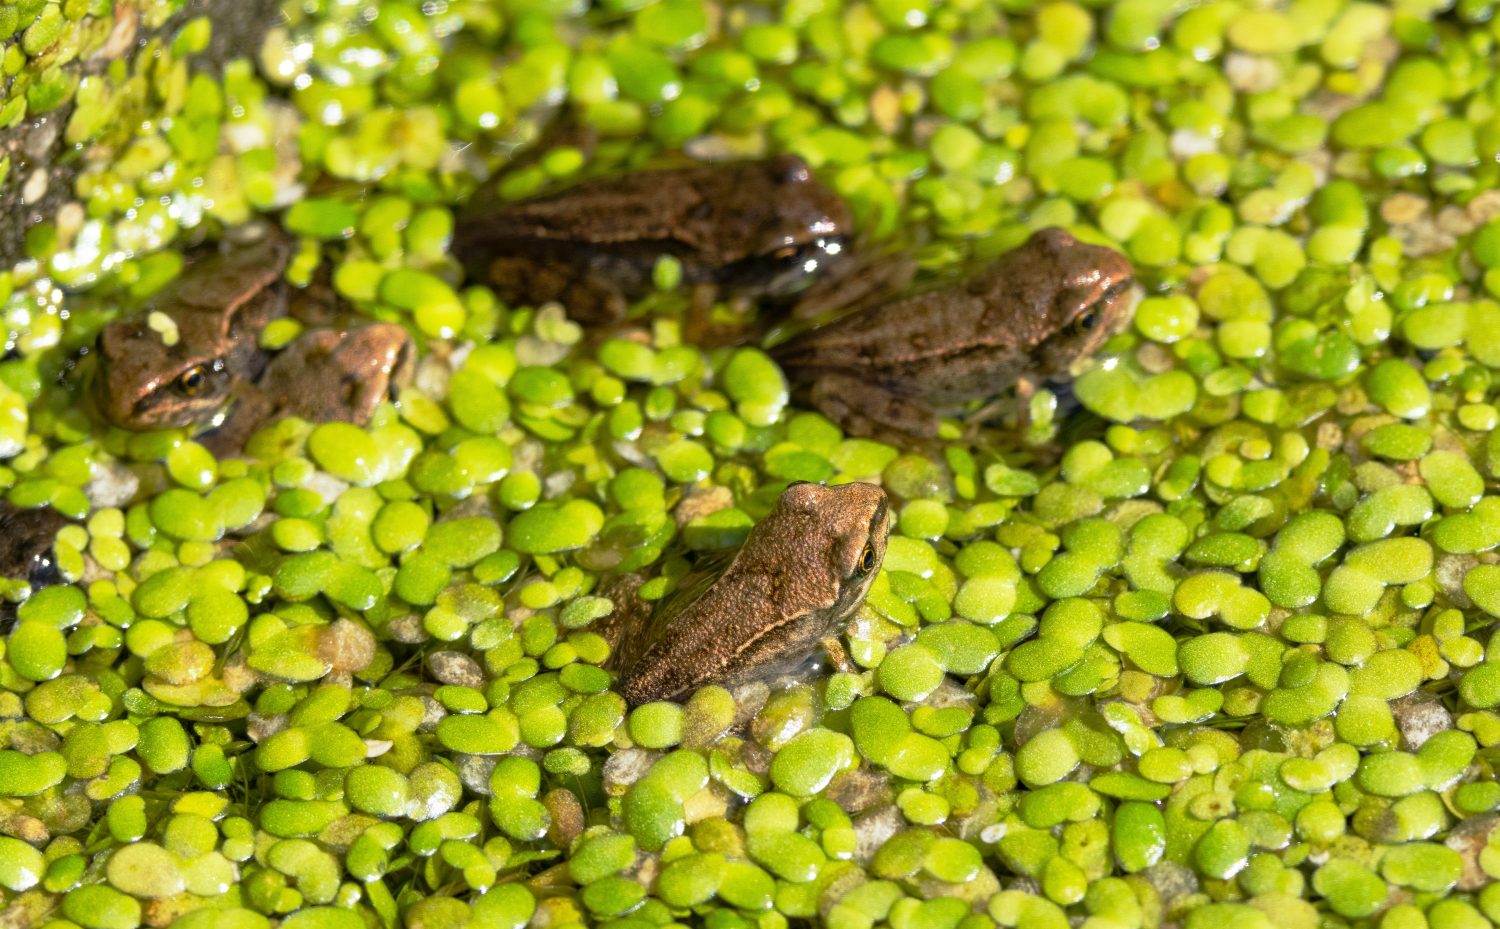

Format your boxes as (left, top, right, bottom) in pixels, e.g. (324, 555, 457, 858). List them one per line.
(600, 482, 891, 705)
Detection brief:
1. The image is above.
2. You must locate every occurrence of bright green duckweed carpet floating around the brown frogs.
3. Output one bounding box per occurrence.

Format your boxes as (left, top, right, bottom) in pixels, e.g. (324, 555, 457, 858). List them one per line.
(0, 0, 1500, 929)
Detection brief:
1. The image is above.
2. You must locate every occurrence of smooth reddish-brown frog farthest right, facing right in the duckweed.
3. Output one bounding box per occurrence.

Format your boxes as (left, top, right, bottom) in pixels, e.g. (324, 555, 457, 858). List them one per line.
(771, 228, 1133, 438)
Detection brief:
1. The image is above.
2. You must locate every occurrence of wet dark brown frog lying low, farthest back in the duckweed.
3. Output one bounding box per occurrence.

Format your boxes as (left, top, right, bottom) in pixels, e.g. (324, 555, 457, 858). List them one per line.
(453, 155, 851, 324)
